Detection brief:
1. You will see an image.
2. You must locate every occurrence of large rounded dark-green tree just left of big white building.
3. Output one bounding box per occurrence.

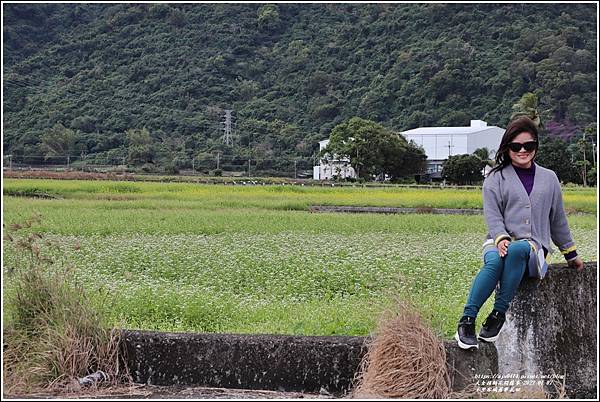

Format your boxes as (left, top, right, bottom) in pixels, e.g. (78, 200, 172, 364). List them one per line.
(321, 117, 426, 179)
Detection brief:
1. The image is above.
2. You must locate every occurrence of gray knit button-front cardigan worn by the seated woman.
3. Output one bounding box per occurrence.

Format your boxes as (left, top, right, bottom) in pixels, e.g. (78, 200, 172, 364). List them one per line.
(483, 164, 575, 254)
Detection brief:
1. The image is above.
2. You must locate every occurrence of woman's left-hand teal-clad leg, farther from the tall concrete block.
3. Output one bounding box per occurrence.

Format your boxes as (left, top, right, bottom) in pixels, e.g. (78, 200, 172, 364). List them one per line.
(463, 251, 504, 318)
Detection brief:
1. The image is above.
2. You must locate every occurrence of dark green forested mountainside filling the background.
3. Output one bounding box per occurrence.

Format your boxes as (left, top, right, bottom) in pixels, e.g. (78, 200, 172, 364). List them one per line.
(3, 3, 597, 168)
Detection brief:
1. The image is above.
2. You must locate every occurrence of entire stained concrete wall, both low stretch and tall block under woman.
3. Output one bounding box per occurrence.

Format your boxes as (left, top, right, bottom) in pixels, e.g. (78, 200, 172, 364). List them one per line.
(124, 263, 597, 398)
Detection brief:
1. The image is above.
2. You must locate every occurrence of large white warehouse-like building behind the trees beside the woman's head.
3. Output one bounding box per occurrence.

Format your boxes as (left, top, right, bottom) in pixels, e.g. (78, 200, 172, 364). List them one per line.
(400, 120, 505, 178)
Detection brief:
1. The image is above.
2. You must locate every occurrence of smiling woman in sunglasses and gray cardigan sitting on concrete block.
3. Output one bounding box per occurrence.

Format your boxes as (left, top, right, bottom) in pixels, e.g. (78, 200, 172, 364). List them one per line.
(455, 117, 583, 349)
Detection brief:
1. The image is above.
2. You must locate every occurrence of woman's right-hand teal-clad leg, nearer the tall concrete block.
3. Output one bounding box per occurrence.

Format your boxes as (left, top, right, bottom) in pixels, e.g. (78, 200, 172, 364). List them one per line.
(494, 240, 531, 313)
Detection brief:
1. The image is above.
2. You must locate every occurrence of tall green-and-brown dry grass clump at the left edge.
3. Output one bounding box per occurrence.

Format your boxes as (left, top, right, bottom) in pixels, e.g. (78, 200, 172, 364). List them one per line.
(3, 217, 130, 394)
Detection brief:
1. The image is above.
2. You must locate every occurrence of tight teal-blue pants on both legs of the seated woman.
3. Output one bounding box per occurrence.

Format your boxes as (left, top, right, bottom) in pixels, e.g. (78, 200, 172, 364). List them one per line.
(463, 240, 531, 318)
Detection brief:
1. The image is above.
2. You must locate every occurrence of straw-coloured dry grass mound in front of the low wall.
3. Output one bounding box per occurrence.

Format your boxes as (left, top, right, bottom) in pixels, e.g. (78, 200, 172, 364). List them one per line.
(353, 303, 451, 399)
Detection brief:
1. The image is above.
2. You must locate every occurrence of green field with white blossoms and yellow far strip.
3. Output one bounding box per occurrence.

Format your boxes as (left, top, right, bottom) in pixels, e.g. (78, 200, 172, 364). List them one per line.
(3, 179, 597, 337)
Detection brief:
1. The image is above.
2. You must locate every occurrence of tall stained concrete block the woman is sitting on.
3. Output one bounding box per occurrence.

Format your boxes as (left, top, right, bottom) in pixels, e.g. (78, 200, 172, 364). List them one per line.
(496, 262, 598, 398)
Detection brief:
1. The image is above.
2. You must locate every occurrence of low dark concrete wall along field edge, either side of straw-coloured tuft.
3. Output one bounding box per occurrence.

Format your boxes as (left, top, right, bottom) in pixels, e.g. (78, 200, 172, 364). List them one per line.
(124, 331, 498, 396)
